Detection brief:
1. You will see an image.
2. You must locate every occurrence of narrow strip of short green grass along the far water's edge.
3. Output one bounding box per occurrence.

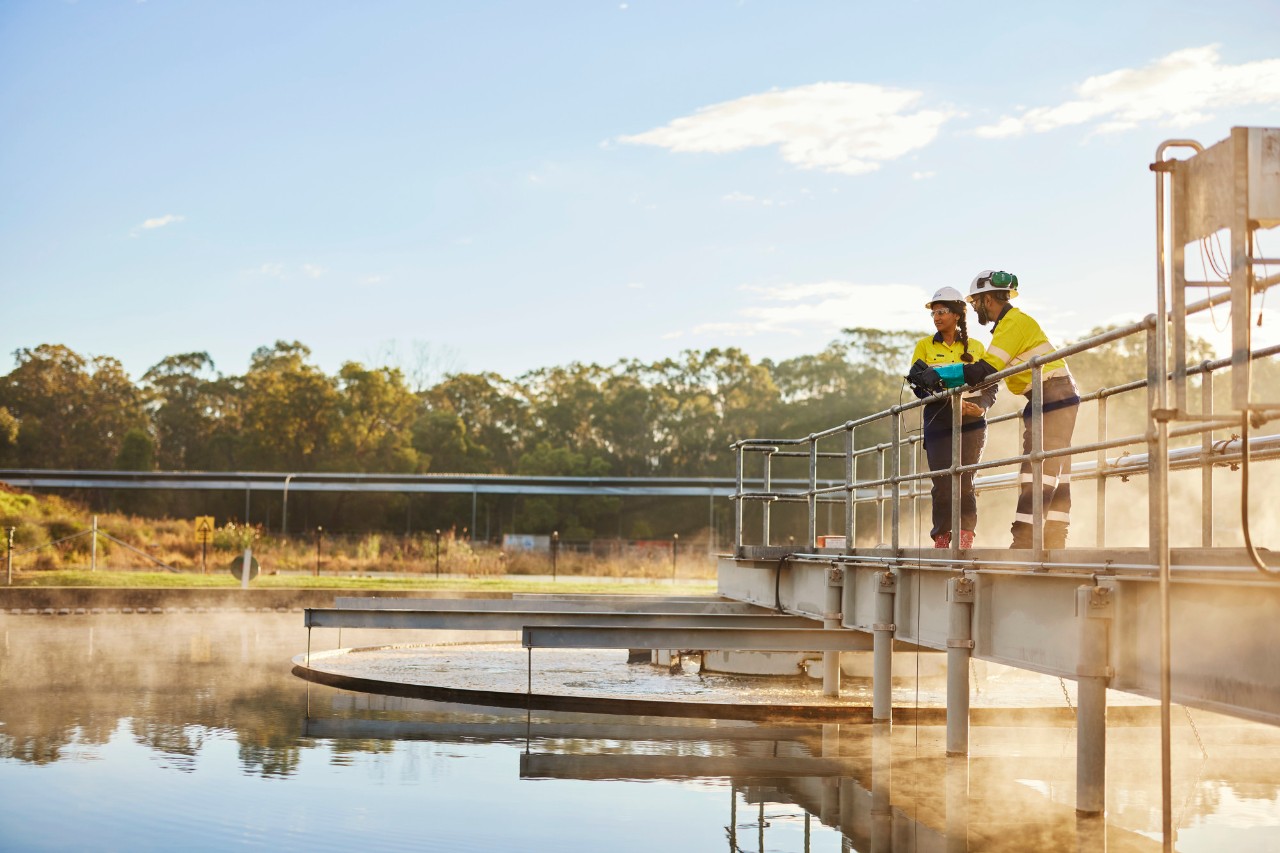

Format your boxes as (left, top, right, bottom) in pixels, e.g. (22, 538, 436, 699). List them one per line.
(5, 570, 716, 596)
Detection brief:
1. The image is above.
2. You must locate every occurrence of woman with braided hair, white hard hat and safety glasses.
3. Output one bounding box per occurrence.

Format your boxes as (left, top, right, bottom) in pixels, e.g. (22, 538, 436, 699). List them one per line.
(906, 287, 996, 548)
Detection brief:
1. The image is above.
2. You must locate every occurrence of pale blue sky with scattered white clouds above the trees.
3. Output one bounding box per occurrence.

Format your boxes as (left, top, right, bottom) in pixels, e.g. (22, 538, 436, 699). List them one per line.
(0, 0, 1280, 379)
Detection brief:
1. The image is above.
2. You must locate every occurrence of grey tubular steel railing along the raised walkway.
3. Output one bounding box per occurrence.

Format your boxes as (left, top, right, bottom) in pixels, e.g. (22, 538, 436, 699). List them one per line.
(731, 293, 1280, 560)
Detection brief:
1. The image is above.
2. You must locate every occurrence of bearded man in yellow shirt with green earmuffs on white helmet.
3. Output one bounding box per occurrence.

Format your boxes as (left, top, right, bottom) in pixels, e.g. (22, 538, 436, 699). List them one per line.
(964, 269, 1080, 548)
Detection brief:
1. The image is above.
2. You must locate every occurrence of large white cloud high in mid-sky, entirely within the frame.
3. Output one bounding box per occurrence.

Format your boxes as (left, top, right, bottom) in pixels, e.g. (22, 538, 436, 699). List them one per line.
(618, 83, 956, 174)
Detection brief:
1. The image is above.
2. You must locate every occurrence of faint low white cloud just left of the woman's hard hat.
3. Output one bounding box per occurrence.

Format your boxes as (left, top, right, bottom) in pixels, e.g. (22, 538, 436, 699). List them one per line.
(691, 280, 928, 348)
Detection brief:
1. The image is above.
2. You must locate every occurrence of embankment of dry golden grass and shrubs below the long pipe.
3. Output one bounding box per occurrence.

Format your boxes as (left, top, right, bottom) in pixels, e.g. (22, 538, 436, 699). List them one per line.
(0, 487, 714, 594)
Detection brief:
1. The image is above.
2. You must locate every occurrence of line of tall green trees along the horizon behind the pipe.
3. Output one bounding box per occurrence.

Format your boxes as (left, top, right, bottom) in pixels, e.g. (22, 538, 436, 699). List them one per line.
(0, 328, 1177, 535)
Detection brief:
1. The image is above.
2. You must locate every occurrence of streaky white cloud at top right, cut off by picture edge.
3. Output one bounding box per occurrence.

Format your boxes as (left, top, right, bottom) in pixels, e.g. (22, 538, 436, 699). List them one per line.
(977, 45, 1280, 138)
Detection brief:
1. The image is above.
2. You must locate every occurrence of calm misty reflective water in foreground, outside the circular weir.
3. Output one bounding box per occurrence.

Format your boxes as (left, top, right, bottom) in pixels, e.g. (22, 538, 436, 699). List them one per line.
(0, 613, 1280, 853)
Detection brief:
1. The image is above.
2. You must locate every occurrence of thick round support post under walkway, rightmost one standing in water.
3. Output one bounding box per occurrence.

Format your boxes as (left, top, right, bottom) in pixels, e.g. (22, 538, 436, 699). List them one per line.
(1075, 587, 1112, 815)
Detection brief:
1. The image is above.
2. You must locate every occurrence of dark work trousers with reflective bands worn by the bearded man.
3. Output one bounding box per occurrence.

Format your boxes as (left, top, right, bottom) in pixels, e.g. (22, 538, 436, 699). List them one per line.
(1012, 377, 1080, 537)
